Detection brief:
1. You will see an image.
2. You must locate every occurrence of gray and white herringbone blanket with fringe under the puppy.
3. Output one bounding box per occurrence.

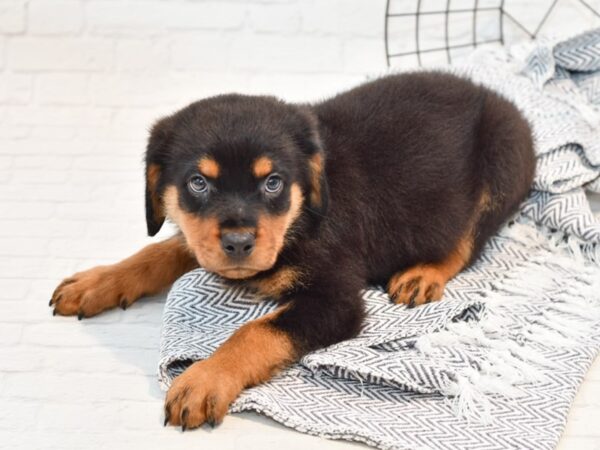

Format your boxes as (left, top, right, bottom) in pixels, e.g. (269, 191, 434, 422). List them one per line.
(159, 30, 600, 449)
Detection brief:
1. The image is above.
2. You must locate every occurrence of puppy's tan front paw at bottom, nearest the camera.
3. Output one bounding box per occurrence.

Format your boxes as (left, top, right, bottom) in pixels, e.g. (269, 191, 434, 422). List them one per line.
(165, 359, 243, 431)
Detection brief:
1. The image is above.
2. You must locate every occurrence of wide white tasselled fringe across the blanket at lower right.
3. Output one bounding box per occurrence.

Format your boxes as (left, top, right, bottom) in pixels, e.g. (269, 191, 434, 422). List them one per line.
(414, 219, 600, 424)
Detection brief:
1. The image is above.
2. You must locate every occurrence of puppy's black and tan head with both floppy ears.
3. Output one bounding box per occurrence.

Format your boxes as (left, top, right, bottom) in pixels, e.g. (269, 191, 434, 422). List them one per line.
(146, 95, 327, 279)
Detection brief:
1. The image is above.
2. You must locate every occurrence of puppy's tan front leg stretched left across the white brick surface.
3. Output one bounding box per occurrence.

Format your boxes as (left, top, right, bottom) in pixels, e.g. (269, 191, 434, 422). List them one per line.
(50, 237, 198, 319)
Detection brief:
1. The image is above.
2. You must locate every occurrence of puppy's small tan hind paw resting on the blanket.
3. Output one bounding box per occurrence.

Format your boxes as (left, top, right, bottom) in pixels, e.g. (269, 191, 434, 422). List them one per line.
(388, 265, 447, 308)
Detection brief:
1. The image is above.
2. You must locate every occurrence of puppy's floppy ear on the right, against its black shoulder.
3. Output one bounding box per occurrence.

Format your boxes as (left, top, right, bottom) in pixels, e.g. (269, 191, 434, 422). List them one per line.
(299, 107, 329, 216)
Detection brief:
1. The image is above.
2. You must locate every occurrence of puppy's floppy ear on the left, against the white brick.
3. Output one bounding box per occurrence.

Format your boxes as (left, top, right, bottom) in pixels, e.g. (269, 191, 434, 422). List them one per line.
(146, 117, 172, 236)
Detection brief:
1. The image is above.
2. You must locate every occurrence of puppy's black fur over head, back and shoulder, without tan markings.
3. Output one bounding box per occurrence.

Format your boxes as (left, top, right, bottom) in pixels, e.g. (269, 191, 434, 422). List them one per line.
(147, 72, 535, 353)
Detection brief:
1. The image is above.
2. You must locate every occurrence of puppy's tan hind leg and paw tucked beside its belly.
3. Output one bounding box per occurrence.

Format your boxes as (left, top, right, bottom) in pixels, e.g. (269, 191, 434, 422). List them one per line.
(387, 237, 473, 307)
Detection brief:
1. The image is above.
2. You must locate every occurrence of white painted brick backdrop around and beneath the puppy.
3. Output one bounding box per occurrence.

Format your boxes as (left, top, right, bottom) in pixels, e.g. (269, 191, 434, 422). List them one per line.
(0, 0, 600, 450)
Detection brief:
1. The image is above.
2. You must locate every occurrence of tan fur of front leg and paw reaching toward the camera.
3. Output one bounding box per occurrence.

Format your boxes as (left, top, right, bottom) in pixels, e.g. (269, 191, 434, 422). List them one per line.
(165, 307, 296, 428)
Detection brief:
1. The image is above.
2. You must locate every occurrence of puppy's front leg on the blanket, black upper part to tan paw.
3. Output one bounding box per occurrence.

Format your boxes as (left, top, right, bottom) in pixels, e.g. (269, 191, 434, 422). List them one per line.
(165, 268, 363, 430)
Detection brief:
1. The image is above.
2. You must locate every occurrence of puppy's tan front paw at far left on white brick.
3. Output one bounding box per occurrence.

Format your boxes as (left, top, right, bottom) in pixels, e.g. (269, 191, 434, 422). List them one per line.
(49, 266, 136, 320)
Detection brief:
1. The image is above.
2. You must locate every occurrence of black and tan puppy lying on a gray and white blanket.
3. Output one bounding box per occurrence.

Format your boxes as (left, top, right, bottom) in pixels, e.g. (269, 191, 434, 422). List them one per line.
(51, 73, 534, 429)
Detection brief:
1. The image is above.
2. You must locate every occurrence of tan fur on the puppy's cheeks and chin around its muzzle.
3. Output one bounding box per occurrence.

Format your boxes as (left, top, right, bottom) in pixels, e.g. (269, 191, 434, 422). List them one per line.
(164, 184, 303, 279)
